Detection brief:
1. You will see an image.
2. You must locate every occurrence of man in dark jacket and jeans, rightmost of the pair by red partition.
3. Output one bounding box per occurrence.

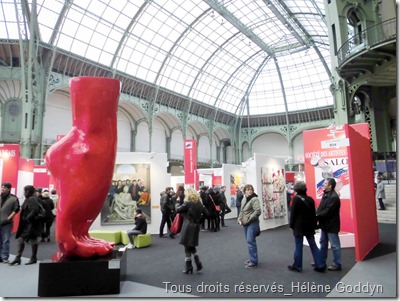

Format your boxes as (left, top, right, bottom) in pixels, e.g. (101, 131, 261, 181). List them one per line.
(317, 178, 342, 271)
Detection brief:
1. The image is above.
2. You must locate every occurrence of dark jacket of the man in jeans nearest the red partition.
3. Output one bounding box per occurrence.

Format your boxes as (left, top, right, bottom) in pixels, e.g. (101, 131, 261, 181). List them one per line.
(317, 190, 340, 233)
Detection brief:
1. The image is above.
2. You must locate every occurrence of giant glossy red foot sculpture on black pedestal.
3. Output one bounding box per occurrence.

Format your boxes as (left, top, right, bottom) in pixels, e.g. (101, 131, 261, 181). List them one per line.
(46, 77, 120, 257)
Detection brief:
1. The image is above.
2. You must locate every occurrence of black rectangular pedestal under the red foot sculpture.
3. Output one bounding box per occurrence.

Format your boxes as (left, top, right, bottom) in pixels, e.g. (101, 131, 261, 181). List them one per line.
(38, 250, 126, 297)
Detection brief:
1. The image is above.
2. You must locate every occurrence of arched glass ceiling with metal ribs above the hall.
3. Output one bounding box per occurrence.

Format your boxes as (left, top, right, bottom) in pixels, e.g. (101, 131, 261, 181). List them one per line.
(0, 0, 333, 115)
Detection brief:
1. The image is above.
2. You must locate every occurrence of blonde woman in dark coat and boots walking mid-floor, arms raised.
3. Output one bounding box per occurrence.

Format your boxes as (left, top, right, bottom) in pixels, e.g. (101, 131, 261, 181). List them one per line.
(177, 188, 208, 274)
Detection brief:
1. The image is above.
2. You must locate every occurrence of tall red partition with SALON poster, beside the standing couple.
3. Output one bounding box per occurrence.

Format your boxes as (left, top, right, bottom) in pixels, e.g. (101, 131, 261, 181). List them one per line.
(303, 124, 379, 261)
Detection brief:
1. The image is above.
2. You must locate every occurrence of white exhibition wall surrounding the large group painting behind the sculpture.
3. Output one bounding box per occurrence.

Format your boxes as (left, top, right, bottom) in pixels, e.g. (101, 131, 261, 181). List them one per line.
(90, 153, 171, 234)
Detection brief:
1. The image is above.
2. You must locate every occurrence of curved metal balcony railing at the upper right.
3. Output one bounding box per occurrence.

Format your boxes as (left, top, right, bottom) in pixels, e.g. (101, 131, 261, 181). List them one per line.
(337, 18, 397, 66)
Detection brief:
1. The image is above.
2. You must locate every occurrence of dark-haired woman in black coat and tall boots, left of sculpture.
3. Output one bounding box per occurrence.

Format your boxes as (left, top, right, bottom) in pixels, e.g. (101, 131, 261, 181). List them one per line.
(10, 185, 42, 265)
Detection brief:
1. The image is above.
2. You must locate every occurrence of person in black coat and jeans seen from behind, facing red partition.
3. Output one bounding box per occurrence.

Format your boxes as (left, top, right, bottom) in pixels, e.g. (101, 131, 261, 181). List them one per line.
(288, 181, 326, 272)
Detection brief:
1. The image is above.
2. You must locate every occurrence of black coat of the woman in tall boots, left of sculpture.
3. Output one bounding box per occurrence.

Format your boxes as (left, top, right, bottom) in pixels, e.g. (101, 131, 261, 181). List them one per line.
(15, 195, 42, 241)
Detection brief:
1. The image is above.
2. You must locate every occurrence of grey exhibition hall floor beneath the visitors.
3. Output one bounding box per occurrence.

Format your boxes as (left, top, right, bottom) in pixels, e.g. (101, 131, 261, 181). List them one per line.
(0, 220, 397, 298)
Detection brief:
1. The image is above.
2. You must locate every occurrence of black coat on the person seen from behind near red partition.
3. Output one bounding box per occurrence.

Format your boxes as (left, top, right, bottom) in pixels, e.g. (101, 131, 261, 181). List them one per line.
(289, 194, 317, 236)
